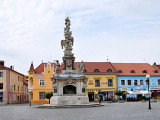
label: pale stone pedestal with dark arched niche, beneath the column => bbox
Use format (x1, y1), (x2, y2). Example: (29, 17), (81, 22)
(50, 73), (89, 106)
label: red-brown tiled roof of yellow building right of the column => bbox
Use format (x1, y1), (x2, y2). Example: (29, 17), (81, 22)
(60, 62), (116, 73)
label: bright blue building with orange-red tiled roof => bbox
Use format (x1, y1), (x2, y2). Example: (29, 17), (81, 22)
(112, 63), (160, 100)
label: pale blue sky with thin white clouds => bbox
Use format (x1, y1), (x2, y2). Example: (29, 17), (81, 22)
(0, 0), (160, 75)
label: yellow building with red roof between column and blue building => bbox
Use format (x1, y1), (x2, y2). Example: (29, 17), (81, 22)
(81, 62), (117, 101)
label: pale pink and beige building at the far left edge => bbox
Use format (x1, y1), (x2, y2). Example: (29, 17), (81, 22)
(0, 61), (27, 104)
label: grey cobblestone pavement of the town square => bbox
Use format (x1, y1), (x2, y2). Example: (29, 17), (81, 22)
(0, 102), (160, 120)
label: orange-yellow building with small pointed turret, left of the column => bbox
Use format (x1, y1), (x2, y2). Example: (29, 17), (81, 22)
(28, 62), (55, 103)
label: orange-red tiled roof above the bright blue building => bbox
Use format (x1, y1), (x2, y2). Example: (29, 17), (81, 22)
(112, 63), (160, 75)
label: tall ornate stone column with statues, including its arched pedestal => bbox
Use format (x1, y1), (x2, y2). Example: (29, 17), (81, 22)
(51, 17), (89, 105)
